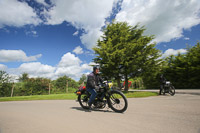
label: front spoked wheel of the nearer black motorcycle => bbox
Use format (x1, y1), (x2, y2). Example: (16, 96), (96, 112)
(108, 91), (128, 113)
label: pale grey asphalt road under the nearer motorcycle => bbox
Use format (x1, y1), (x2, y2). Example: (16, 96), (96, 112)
(0, 94), (200, 133)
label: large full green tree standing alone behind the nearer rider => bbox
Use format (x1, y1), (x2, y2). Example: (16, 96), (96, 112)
(93, 22), (160, 91)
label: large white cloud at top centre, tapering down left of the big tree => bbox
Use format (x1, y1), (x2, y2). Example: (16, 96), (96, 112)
(45, 0), (116, 49)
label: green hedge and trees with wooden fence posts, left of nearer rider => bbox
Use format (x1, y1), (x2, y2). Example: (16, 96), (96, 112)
(0, 71), (86, 97)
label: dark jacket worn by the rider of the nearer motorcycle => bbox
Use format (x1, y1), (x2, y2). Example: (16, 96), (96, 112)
(86, 72), (103, 89)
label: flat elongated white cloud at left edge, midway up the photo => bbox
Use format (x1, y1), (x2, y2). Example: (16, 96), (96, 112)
(0, 50), (42, 62)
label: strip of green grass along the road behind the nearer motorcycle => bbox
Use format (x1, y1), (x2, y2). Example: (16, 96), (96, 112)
(0, 92), (158, 102)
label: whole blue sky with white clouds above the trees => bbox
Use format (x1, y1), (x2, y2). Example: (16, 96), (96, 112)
(0, 0), (200, 80)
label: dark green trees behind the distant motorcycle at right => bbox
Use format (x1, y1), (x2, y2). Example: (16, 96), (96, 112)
(142, 42), (200, 89)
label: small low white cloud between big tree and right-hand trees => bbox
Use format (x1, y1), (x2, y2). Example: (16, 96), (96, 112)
(161, 49), (187, 58)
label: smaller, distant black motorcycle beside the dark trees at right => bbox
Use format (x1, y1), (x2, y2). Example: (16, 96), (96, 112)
(161, 81), (175, 96)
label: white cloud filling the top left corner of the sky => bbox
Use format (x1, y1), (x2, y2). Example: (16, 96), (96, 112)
(0, 0), (42, 28)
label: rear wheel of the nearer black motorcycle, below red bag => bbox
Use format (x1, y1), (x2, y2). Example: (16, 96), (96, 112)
(78, 93), (89, 109)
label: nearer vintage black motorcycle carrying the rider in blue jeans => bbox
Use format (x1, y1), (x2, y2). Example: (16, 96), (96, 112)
(76, 81), (128, 113)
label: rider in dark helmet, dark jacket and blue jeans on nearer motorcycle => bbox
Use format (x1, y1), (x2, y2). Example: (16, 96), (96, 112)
(86, 66), (103, 108)
